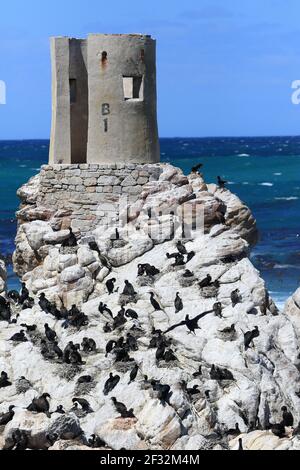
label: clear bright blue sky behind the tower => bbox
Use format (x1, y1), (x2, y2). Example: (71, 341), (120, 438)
(0, 0), (300, 139)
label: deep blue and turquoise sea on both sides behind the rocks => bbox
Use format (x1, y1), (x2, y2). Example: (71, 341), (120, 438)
(0, 137), (300, 305)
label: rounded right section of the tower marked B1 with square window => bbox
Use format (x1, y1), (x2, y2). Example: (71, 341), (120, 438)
(87, 34), (160, 163)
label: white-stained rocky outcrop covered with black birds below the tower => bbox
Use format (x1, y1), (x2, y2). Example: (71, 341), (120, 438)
(0, 165), (300, 450)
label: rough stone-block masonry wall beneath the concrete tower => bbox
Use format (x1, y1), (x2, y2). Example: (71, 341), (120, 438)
(36, 164), (163, 233)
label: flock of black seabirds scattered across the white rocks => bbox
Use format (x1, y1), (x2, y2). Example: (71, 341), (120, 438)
(0, 183), (292, 449)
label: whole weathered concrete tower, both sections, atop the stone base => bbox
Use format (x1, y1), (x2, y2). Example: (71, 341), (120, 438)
(49, 34), (160, 164)
